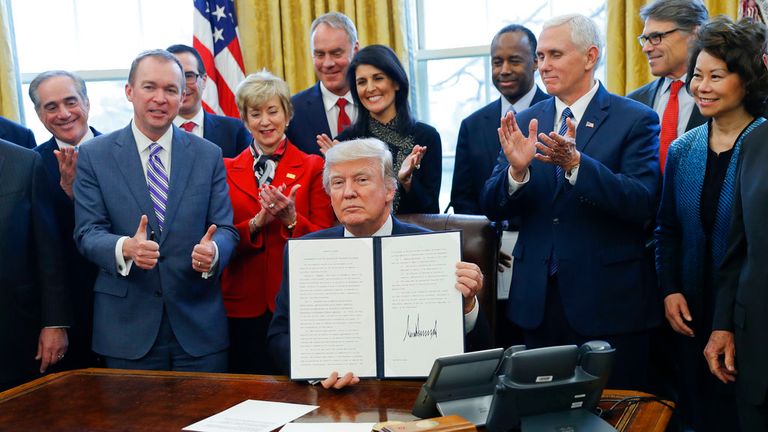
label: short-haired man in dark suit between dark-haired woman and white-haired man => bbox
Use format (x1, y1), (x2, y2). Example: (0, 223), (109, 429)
(451, 24), (549, 214)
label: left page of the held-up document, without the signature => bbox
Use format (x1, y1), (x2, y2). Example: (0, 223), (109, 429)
(288, 238), (376, 379)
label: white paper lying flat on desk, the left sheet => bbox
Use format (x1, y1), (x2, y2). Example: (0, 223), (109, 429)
(182, 399), (317, 432)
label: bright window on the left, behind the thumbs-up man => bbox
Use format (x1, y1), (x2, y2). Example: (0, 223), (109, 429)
(11, 0), (193, 143)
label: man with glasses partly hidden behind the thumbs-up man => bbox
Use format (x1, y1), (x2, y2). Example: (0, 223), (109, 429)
(167, 44), (251, 158)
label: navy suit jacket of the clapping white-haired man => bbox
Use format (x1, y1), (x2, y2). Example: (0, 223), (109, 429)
(480, 84), (659, 336)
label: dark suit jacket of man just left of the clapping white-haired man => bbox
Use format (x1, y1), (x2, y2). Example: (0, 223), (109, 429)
(451, 86), (551, 215)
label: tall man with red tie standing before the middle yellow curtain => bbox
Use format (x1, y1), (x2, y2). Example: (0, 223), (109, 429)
(285, 12), (360, 156)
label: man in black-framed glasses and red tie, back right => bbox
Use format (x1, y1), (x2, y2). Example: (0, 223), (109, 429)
(627, 0), (709, 172)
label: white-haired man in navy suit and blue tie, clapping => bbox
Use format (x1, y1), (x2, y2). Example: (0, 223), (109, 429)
(480, 14), (660, 388)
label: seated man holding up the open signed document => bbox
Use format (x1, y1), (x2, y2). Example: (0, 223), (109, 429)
(267, 138), (488, 388)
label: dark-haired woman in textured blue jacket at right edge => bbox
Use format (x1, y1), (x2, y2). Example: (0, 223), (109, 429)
(656, 17), (768, 432)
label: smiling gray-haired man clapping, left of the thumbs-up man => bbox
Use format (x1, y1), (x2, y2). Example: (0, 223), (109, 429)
(29, 70), (100, 369)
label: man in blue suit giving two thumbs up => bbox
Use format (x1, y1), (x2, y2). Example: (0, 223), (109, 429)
(74, 50), (239, 372)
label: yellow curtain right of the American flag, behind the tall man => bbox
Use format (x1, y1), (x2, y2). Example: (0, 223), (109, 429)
(235, 0), (408, 93)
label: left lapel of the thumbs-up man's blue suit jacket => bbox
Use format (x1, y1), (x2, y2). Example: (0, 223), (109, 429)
(112, 124), (160, 232)
